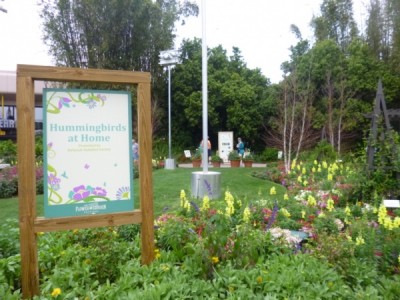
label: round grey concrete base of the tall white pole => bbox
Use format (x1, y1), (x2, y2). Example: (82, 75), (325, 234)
(192, 171), (221, 199)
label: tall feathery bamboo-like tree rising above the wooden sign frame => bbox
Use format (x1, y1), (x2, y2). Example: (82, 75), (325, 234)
(41, 0), (198, 73)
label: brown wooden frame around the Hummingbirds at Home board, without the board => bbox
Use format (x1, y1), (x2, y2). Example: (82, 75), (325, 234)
(16, 65), (154, 298)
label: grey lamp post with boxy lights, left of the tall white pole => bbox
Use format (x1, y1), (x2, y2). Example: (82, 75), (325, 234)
(159, 50), (180, 169)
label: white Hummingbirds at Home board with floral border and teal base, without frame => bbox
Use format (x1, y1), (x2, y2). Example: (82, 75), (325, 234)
(43, 89), (134, 218)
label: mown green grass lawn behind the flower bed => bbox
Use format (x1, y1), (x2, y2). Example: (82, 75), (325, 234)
(0, 168), (285, 220)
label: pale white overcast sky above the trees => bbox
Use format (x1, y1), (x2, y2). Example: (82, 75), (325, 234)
(0, 0), (369, 83)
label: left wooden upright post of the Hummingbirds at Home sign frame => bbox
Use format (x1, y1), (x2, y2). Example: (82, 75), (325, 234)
(16, 72), (39, 298)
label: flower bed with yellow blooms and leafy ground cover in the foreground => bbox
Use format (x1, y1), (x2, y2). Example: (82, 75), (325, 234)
(0, 161), (400, 299)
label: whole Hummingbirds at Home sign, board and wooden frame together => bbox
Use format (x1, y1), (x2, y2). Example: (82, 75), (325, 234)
(16, 65), (154, 298)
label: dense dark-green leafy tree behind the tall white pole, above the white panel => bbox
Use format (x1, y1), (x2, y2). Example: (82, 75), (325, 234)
(173, 39), (269, 150)
